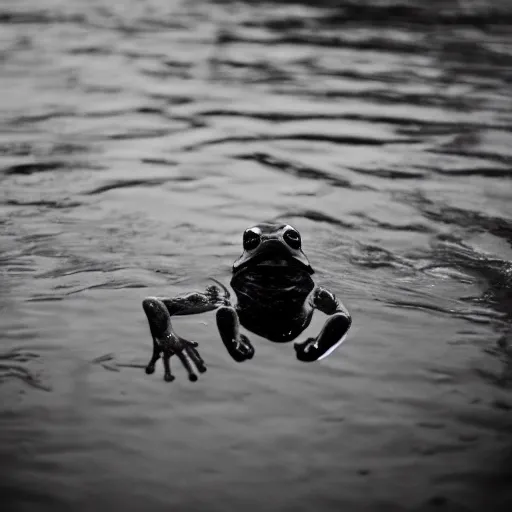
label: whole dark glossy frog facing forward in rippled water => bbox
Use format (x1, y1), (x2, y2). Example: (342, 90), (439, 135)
(142, 223), (352, 382)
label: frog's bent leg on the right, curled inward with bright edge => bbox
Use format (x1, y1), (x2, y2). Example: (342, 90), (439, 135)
(294, 287), (352, 362)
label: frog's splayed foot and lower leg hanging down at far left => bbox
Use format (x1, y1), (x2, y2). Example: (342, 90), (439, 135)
(142, 297), (206, 382)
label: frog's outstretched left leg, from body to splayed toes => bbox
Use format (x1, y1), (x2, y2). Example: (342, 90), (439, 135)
(142, 283), (230, 382)
